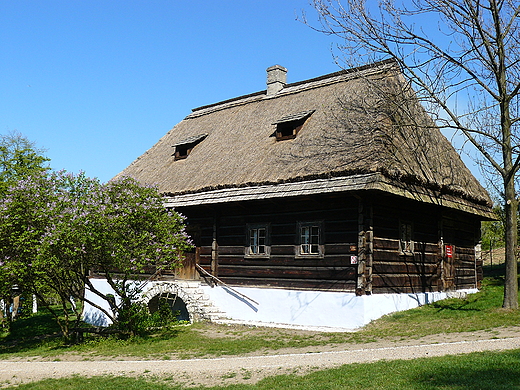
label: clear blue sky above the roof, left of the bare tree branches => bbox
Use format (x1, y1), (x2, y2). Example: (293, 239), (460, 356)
(0, 0), (346, 181)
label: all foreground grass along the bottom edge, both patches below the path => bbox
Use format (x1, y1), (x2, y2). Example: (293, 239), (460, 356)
(7, 350), (520, 390)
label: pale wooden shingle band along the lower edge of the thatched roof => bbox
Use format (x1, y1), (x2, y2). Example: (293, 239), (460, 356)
(164, 173), (494, 219)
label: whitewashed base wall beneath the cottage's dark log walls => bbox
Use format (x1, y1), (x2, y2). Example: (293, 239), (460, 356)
(83, 279), (477, 330)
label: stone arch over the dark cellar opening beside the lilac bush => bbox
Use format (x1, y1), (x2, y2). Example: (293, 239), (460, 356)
(140, 282), (198, 322)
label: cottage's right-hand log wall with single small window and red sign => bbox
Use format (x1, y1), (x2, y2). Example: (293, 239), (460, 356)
(372, 196), (482, 293)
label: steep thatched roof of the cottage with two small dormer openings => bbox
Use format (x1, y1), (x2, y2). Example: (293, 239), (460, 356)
(118, 61), (491, 214)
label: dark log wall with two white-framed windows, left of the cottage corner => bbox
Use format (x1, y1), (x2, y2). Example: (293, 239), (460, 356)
(183, 196), (358, 292)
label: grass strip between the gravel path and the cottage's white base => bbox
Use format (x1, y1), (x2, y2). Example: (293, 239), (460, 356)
(0, 266), (520, 359)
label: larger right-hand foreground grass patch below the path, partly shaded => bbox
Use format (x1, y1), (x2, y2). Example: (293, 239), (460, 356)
(254, 350), (520, 390)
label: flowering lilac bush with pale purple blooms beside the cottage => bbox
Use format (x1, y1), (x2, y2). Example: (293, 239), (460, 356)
(0, 171), (191, 336)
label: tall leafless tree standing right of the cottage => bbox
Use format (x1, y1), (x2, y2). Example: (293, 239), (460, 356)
(306, 0), (520, 309)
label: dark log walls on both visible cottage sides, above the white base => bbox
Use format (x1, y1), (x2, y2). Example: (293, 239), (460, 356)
(180, 193), (482, 294)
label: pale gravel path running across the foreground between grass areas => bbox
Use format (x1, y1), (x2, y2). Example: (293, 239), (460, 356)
(0, 328), (520, 387)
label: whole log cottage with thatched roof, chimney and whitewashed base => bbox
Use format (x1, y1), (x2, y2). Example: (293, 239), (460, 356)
(84, 61), (491, 328)
